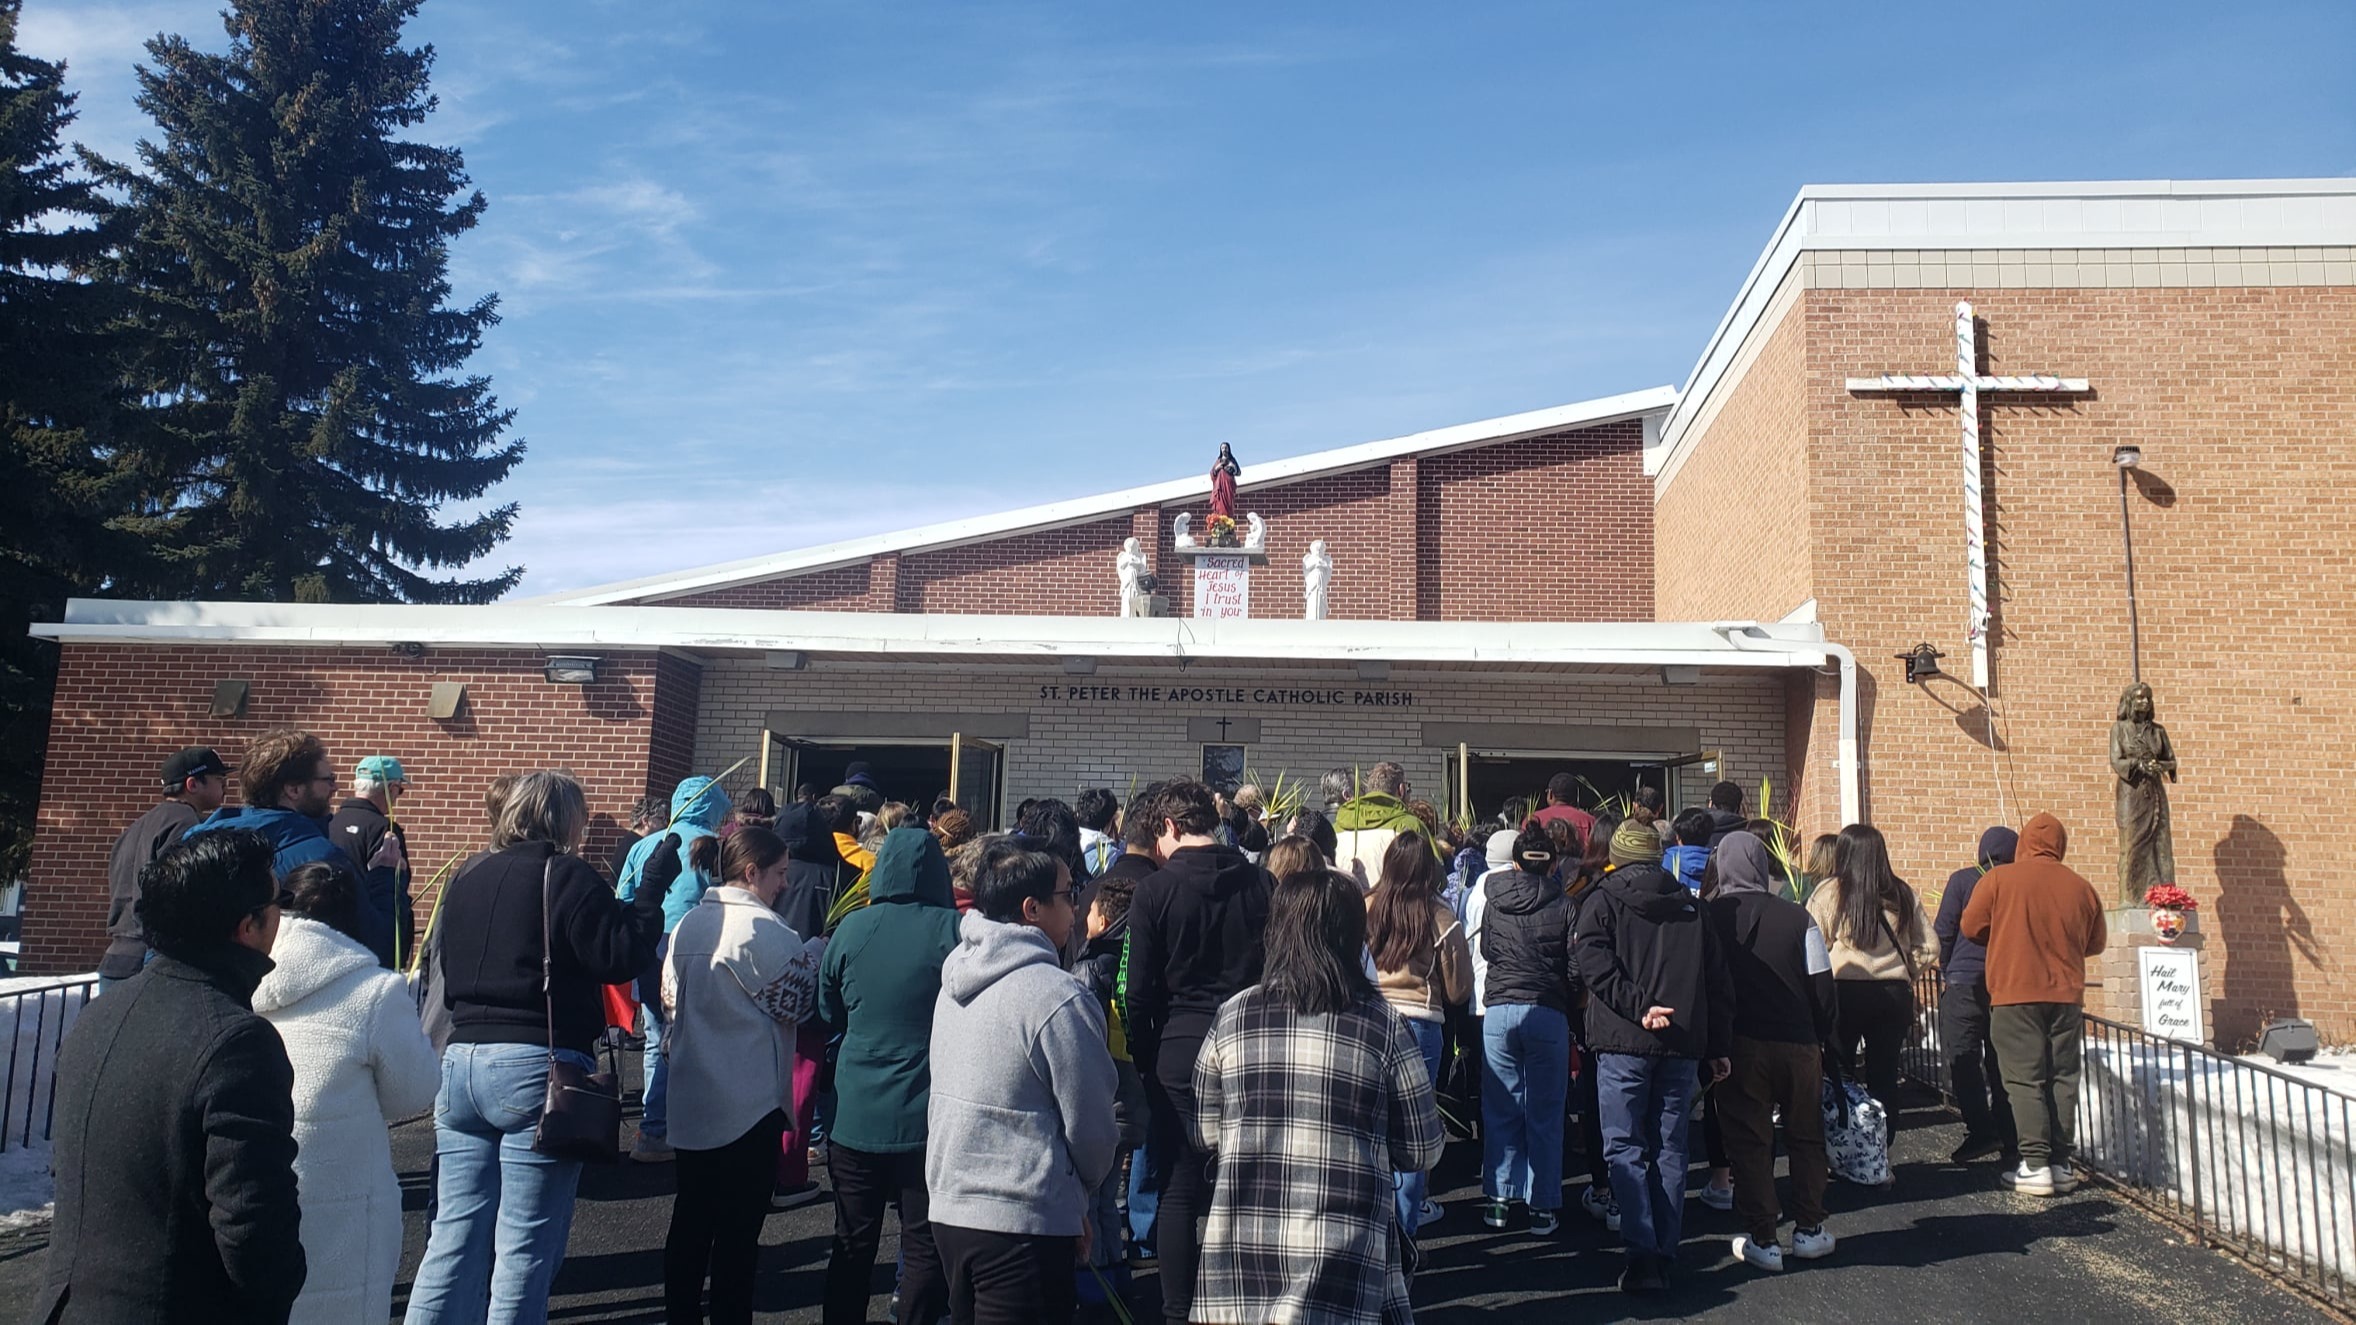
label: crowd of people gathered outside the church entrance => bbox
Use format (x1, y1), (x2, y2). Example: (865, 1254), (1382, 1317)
(42, 731), (2104, 1325)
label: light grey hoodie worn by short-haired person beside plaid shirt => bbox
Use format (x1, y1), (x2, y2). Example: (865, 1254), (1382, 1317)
(924, 912), (1119, 1238)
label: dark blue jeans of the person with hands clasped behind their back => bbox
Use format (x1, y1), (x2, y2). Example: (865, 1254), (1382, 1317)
(1592, 1046), (1701, 1259)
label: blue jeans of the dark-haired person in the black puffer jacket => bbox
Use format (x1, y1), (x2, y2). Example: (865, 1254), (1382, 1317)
(1480, 1002), (1571, 1209)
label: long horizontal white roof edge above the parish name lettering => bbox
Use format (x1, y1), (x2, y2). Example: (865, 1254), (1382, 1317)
(33, 599), (1826, 667)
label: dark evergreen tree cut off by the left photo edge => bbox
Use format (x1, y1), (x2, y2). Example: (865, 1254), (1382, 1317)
(0, 0), (144, 882)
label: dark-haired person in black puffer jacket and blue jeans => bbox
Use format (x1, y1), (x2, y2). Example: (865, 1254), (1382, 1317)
(1480, 820), (1579, 1238)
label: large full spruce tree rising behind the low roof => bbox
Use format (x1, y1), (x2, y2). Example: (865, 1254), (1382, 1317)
(101, 0), (523, 604)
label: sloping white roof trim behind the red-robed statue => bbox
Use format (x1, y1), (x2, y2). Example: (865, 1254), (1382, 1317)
(516, 387), (1677, 606)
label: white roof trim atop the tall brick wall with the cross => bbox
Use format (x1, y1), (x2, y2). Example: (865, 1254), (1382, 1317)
(1647, 179), (2356, 474)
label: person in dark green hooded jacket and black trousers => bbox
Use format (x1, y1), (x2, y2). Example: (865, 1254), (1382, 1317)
(818, 828), (957, 1325)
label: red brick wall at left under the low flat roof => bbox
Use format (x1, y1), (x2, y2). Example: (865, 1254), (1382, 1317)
(24, 644), (697, 971)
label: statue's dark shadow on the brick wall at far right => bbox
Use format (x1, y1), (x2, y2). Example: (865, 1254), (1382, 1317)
(2210, 813), (2323, 1049)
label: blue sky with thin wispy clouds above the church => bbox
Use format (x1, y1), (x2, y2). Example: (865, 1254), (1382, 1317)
(21, 0), (2356, 592)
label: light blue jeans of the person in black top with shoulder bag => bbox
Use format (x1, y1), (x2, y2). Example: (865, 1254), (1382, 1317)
(408, 1044), (596, 1325)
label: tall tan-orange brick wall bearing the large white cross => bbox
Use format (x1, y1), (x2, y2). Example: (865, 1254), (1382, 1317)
(1663, 285), (2356, 1047)
